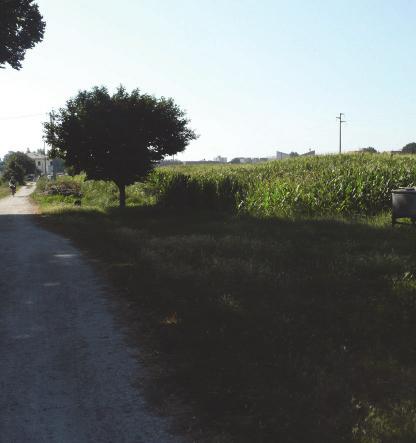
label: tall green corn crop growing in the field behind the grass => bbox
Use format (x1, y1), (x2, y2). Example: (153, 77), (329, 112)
(149, 154), (416, 216)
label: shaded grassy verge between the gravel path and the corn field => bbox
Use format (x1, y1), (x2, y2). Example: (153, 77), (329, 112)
(36, 196), (416, 443)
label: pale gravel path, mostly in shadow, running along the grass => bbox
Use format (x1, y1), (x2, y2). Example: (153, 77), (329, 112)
(0, 187), (179, 443)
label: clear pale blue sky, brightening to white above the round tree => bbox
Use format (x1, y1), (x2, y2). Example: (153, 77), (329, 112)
(0, 0), (416, 160)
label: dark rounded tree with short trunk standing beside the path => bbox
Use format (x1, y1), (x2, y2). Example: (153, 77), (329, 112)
(44, 86), (197, 207)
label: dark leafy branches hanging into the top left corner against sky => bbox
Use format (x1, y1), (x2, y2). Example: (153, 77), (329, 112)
(0, 0), (45, 69)
